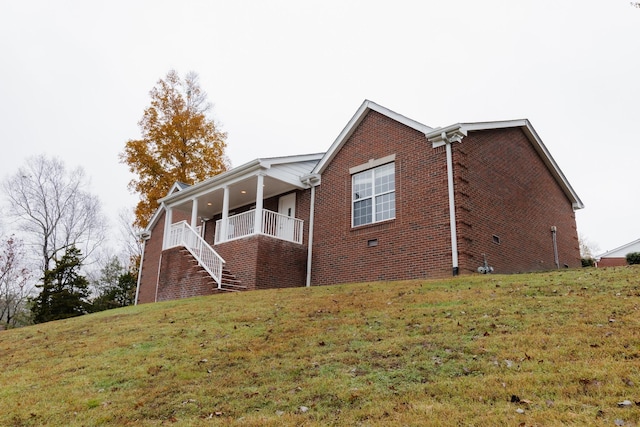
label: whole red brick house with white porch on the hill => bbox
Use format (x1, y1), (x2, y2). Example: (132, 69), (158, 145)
(137, 101), (583, 303)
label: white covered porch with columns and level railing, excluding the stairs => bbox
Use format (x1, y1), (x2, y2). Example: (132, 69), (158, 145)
(160, 155), (319, 249)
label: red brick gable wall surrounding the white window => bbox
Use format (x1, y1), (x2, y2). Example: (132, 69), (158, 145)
(312, 111), (451, 285)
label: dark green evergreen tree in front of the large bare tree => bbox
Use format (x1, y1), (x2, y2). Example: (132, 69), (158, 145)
(31, 246), (89, 323)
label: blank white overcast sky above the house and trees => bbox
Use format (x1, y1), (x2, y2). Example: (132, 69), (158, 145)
(0, 0), (640, 251)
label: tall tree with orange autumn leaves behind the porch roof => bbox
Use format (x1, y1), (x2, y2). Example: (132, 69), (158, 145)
(120, 70), (229, 227)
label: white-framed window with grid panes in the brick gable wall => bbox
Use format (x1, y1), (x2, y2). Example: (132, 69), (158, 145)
(351, 162), (396, 227)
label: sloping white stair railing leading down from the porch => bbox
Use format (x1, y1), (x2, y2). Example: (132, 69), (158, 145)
(165, 221), (224, 289)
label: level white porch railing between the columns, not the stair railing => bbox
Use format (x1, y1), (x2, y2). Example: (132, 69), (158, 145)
(214, 209), (304, 244)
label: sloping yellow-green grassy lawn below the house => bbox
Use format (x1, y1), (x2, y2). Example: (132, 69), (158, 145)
(0, 267), (640, 426)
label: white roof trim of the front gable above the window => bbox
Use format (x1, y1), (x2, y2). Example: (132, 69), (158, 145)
(312, 99), (433, 174)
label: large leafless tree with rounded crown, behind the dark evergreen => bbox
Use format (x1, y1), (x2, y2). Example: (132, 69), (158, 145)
(3, 155), (107, 277)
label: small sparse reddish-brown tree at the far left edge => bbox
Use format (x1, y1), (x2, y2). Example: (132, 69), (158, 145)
(0, 236), (33, 327)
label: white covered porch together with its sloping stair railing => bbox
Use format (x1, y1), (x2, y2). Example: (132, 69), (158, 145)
(160, 154), (321, 287)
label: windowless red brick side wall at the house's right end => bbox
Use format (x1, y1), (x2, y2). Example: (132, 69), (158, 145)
(453, 128), (581, 273)
